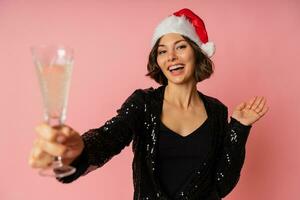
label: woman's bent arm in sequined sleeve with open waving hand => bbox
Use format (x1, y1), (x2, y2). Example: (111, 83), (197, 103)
(216, 96), (269, 197)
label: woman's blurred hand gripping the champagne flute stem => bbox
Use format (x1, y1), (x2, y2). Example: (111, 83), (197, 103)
(28, 123), (84, 168)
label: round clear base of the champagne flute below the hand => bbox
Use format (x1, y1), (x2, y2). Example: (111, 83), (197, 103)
(39, 163), (76, 178)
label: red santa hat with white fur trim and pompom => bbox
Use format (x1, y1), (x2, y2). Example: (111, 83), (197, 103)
(151, 8), (215, 57)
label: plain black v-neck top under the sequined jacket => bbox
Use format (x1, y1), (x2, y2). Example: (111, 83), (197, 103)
(157, 98), (212, 197)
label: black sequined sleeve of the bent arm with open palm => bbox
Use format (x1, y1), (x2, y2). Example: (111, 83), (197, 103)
(215, 107), (252, 197)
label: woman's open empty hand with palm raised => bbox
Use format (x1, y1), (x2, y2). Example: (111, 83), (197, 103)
(232, 96), (269, 125)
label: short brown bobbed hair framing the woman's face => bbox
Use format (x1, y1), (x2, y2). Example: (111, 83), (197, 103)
(146, 35), (214, 85)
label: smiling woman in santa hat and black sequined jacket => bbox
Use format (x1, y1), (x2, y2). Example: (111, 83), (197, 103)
(29, 9), (268, 200)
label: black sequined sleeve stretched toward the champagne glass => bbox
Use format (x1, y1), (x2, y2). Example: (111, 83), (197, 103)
(58, 89), (144, 183)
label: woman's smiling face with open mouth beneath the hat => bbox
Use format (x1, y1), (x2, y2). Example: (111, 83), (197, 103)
(157, 33), (195, 84)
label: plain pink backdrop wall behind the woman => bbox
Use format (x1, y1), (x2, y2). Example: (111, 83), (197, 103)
(0, 0), (300, 200)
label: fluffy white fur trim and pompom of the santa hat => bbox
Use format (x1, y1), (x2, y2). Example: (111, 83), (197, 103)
(151, 15), (215, 57)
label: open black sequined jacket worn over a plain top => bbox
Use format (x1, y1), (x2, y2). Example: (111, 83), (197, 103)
(58, 86), (251, 200)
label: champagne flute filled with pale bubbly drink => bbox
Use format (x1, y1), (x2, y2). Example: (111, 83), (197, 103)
(31, 45), (76, 178)
